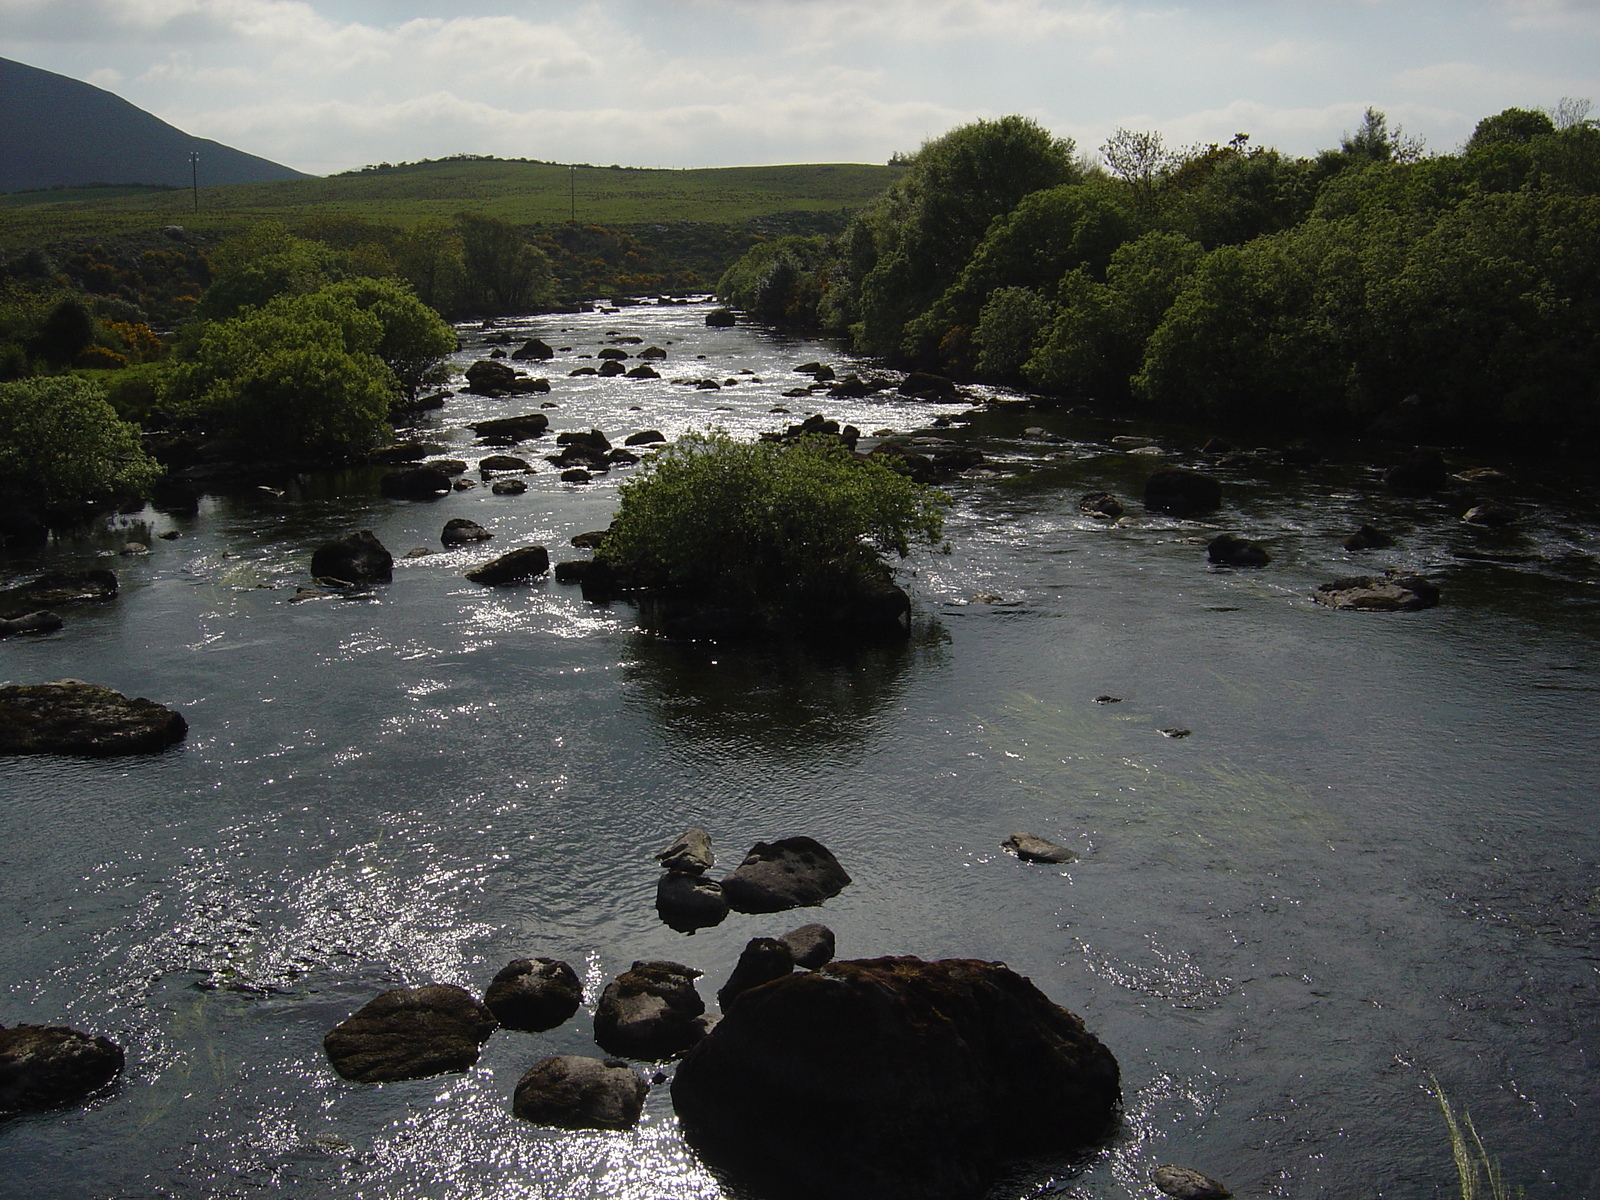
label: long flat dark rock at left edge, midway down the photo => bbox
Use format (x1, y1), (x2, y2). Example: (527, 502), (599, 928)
(0, 678), (189, 758)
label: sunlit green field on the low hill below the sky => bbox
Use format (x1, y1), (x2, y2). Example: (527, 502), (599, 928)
(0, 158), (901, 246)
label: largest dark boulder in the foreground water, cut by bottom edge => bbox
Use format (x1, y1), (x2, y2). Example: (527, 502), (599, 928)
(672, 958), (1120, 1200)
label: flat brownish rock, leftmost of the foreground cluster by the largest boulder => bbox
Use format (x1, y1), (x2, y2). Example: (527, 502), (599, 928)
(322, 984), (496, 1083)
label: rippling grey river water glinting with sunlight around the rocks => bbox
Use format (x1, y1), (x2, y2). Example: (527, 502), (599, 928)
(0, 306), (1600, 1200)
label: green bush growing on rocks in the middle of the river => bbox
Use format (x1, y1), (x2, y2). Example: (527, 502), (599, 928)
(602, 432), (949, 605)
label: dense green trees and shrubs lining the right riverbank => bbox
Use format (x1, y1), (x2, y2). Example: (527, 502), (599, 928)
(718, 102), (1600, 440)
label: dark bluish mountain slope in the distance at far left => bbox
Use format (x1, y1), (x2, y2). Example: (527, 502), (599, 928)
(0, 58), (310, 192)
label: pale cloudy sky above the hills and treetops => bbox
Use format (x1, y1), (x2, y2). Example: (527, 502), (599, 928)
(0, 0), (1600, 174)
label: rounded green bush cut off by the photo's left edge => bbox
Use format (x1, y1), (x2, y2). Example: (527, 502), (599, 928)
(0, 376), (162, 507)
